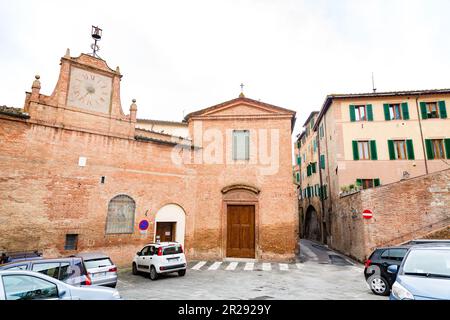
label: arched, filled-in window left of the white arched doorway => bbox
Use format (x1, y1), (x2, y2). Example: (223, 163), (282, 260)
(106, 195), (136, 234)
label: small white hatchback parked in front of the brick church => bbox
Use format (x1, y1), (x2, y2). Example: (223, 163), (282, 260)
(132, 242), (187, 280)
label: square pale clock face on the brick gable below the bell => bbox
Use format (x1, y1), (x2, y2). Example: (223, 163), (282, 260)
(67, 67), (112, 113)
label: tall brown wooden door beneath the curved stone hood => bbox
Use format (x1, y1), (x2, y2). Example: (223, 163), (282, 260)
(227, 205), (255, 259)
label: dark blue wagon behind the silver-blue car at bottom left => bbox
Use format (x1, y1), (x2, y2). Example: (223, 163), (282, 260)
(0, 258), (92, 286)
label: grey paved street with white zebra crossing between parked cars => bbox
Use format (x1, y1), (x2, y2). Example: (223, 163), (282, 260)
(117, 240), (386, 300)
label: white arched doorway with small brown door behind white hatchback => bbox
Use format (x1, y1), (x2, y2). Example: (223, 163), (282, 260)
(155, 204), (186, 246)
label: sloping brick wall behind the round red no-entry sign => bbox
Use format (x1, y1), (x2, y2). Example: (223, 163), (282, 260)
(331, 169), (450, 261)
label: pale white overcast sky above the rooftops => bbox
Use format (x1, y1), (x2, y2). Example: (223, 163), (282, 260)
(0, 0), (450, 132)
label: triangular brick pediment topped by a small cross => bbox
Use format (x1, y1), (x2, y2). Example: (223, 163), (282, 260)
(185, 97), (295, 120)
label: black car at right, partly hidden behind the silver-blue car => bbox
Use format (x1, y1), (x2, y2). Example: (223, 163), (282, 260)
(364, 245), (411, 296)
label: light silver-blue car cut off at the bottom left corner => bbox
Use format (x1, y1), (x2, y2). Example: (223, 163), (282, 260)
(0, 270), (121, 300)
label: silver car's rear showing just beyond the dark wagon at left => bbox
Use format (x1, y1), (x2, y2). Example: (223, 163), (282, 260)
(75, 252), (117, 288)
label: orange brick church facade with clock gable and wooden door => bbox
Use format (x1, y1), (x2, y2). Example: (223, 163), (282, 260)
(0, 51), (298, 265)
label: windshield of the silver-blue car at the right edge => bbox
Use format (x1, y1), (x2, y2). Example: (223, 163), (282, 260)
(403, 249), (450, 278)
